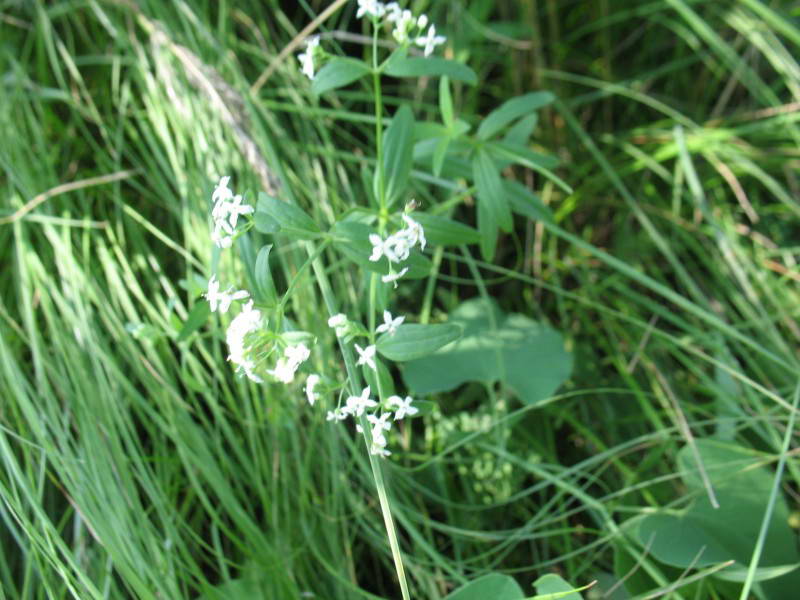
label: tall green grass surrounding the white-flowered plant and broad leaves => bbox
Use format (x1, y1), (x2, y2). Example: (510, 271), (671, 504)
(0, 0), (800, 599)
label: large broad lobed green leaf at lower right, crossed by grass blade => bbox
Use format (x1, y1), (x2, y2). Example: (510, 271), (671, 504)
(637, 439), (800, 600)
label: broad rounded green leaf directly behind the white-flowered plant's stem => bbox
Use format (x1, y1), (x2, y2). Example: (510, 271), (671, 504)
(403, 299), (572, 404)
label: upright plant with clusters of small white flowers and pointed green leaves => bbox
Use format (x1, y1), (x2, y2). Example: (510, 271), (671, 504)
(200, 0), (560, 600)
